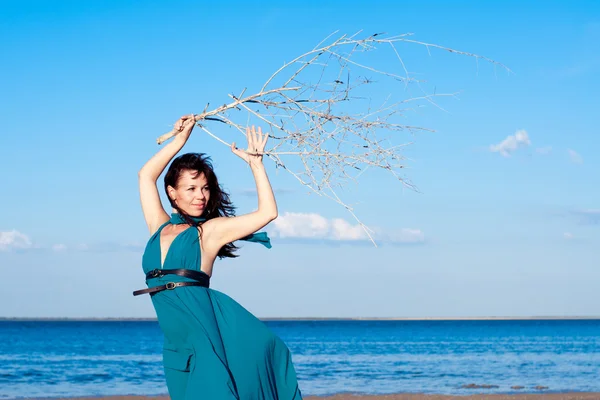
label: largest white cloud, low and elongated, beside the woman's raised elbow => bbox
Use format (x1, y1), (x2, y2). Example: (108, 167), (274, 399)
(270, 212), (425, 243)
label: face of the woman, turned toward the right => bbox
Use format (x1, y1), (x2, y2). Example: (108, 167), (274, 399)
(169, 170), (210, 217)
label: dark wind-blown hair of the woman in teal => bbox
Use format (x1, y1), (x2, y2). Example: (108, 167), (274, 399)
(165, 153), (237, 258)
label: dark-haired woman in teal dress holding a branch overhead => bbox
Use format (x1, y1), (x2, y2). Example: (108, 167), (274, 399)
(134, 115), (302, 400)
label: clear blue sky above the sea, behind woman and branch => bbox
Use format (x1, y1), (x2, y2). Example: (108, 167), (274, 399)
(0, 1), (600, 317)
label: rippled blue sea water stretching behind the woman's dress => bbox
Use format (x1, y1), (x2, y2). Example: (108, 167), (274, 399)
(0, 320), (600, 399)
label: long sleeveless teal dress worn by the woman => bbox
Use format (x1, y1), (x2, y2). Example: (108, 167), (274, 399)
(142, 214), (302, 400)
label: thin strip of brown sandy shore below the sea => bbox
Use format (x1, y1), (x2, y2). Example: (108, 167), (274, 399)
(51, 393), (600, 400)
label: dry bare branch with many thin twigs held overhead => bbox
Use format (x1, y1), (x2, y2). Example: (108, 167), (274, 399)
(157, 32), (508, 244)
